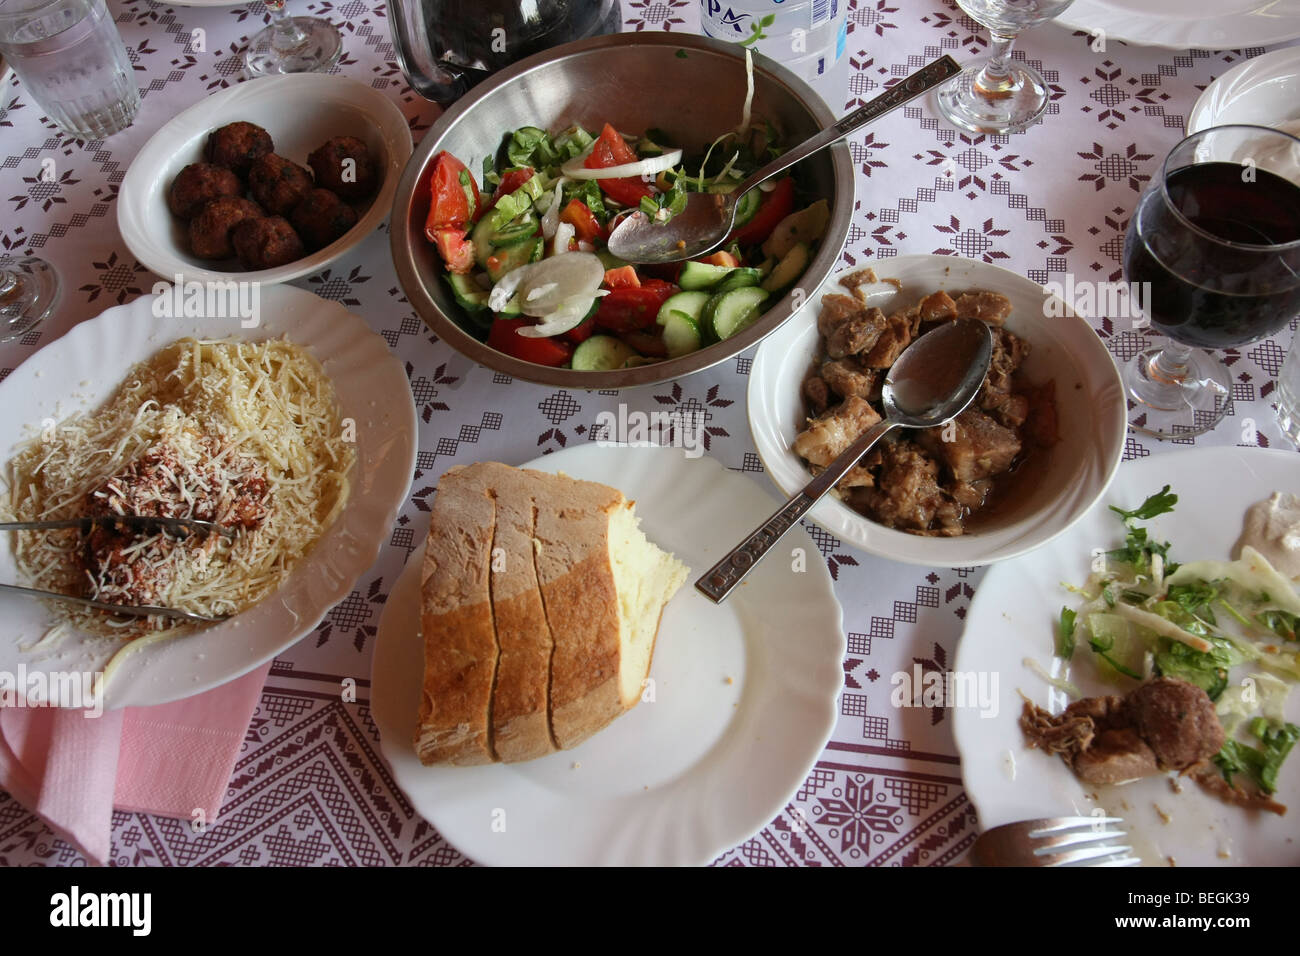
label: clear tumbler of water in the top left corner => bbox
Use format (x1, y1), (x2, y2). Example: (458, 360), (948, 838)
(0, 0), (140, 139)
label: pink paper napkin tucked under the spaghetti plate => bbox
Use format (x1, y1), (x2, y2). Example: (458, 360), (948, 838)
(0, 663), (270, 864)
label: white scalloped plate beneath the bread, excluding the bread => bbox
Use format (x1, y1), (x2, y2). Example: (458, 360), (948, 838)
(371, 444), (845, 866)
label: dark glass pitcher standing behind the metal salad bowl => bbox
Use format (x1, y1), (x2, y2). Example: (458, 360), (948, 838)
(389, 0), (620, 105)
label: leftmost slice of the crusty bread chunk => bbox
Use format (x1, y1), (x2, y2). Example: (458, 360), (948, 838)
(415, 468), (498, 765)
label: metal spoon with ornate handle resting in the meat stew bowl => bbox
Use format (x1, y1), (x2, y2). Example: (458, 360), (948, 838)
(696, 319), (993, 604)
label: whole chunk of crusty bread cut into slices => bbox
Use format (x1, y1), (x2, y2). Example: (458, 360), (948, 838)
(416, 462), (688, 763)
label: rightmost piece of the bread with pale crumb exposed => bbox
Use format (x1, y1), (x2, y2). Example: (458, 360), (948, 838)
(534, 472), (688, 749)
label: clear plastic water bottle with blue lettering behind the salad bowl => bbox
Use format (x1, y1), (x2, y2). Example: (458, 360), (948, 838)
(699, 0), (849, 116)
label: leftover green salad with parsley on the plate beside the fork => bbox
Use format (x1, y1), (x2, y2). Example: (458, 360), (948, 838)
(1052, 485), (1300, 795)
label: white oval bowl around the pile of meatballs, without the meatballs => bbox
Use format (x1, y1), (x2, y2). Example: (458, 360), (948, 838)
(117, 73), (411, 284)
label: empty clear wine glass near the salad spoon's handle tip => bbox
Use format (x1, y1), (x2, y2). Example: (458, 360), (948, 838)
(936, 0), (1074, 133)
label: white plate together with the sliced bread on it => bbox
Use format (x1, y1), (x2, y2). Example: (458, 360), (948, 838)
(372, 444), (845, 865)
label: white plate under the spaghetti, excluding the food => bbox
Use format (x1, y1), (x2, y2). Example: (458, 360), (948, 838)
(0, 280), (416, 708)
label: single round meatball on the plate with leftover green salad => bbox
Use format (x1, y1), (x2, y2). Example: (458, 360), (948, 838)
(1128, 678), (1223, 770)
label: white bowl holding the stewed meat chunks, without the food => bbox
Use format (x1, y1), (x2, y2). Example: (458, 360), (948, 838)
(749, 255), (1127, 567)
